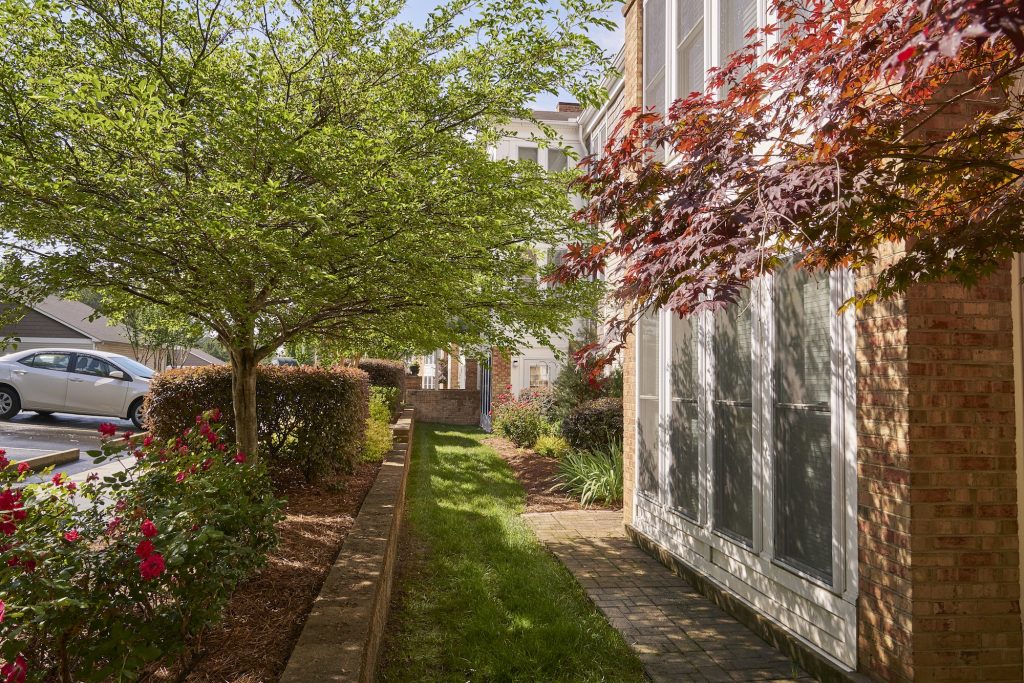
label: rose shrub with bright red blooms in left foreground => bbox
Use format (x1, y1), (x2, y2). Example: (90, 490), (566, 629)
(0, 412), (280, 683)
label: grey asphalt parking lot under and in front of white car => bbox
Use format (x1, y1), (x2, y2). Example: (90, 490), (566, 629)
(0, 413), (137, 474)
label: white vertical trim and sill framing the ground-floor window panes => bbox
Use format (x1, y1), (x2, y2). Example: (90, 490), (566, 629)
(632, 270), (857, 605)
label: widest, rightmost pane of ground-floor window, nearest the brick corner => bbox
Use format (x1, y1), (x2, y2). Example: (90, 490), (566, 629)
(773, 267), (833, 581)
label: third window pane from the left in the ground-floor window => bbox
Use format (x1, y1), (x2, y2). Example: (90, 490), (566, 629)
(712, 292), (754, 544)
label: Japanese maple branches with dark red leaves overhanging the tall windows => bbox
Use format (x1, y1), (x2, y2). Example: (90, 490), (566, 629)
(555, 0), (1024, 362)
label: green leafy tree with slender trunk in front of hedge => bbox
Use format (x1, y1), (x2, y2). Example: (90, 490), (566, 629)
(0, 0), (612, 452)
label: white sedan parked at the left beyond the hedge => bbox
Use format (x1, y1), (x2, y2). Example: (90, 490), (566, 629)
(0, 348), (154, 428)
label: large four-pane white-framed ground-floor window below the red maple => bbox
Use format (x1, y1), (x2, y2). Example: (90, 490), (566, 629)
(635, 266), (856, 595)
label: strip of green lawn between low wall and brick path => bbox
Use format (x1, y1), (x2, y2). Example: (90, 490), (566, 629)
(380, 424), (645, 683)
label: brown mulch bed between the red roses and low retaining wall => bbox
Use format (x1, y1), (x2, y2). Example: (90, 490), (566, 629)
(147, 463), (381, 683)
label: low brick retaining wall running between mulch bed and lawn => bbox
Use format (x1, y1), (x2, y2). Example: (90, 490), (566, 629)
(281, 409), (415, 683)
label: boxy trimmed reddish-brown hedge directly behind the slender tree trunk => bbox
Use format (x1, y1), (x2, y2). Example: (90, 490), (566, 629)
(144, 366), (370, 479)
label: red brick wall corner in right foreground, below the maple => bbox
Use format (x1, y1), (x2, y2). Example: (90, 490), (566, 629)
(857, 253), (1024, 681)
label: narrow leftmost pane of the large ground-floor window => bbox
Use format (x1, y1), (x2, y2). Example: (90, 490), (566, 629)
(637, 312), (658, 498)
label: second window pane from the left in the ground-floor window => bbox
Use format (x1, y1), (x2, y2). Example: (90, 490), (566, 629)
(669, 314), (700, 518)
